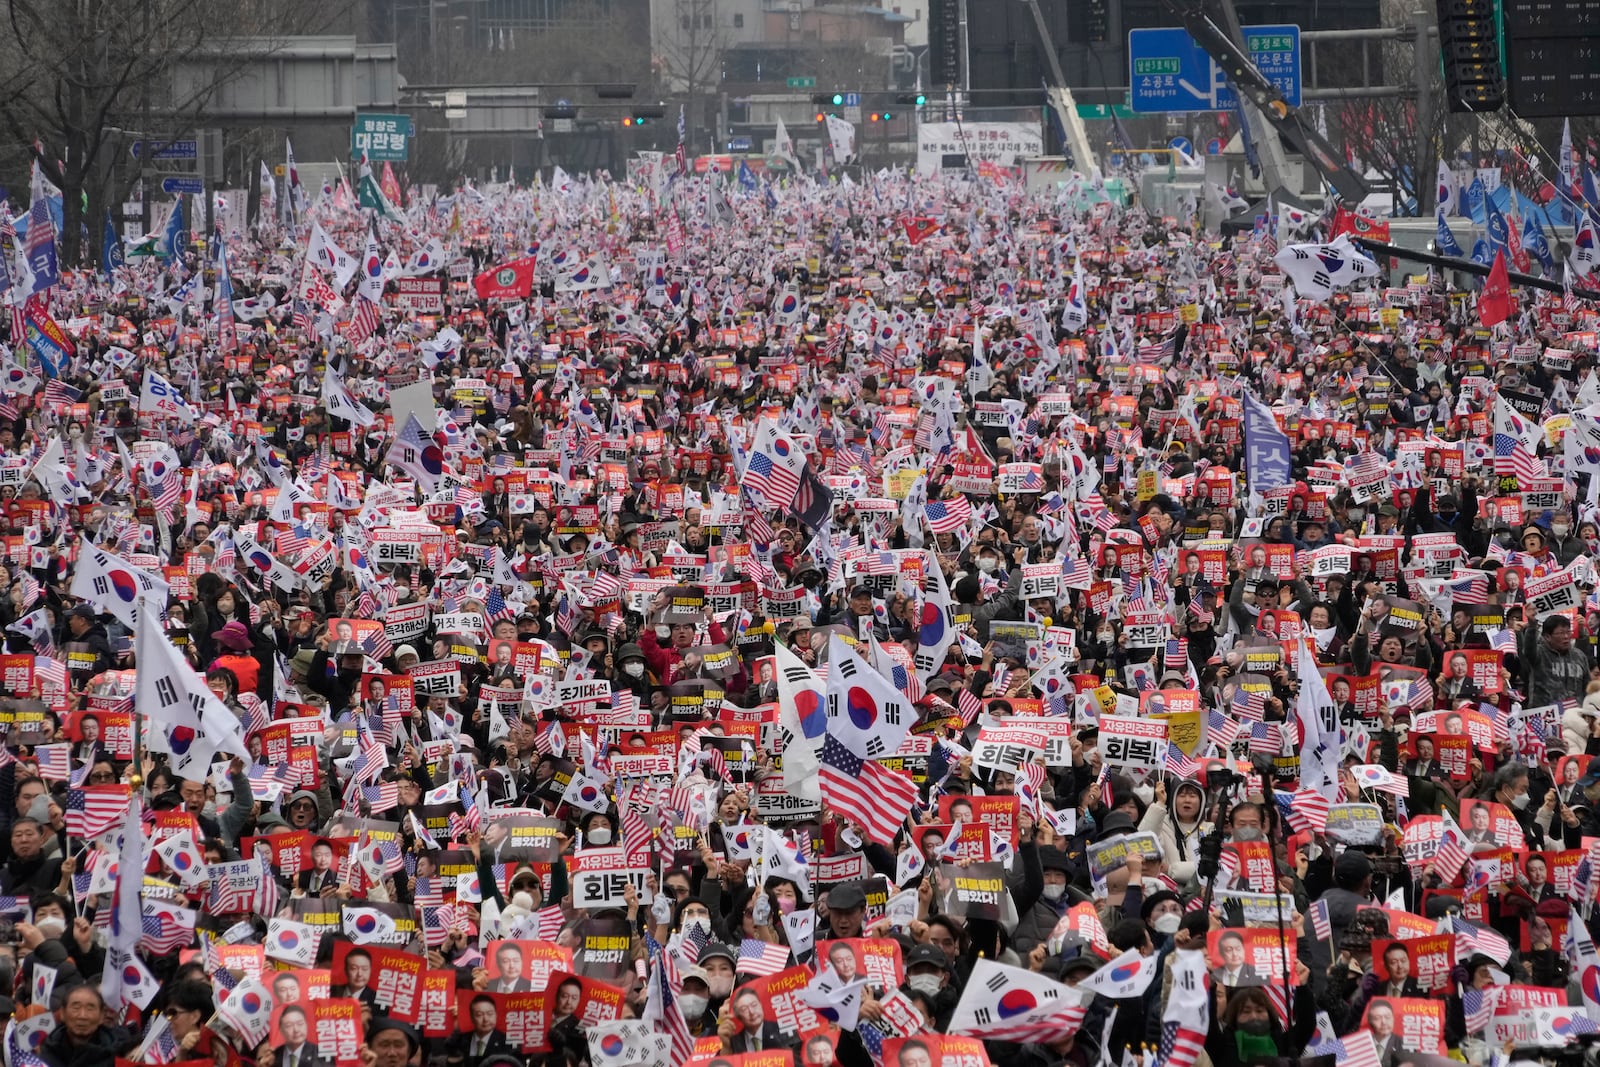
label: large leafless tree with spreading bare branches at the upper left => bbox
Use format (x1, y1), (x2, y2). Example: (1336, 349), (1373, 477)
(0, 0), (349, 264)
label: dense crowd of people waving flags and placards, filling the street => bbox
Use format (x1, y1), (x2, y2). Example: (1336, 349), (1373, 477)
(0, 147), (1600, 1067)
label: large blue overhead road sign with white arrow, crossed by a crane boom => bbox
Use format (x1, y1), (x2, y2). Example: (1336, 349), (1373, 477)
(1128, 26), (1301, 112)
